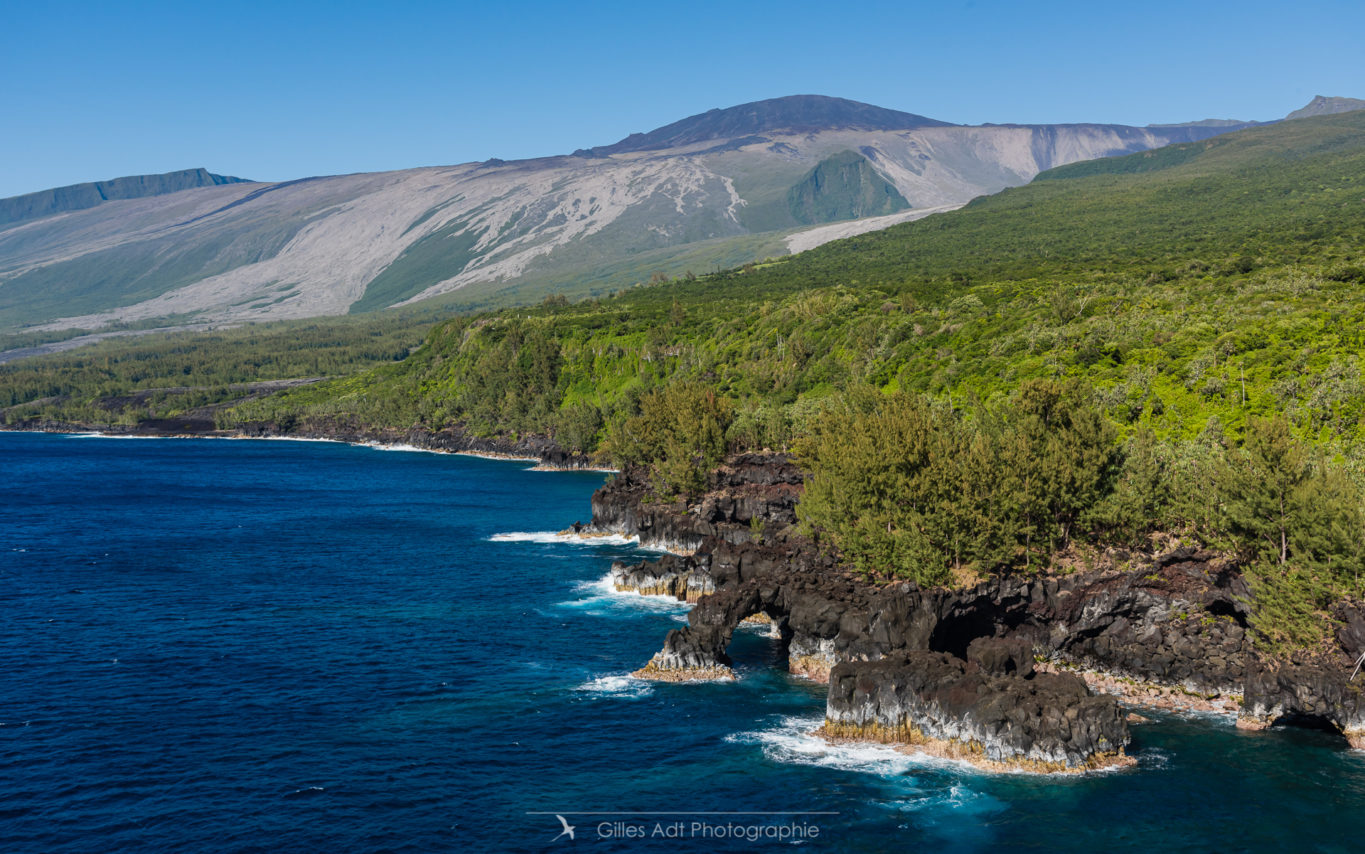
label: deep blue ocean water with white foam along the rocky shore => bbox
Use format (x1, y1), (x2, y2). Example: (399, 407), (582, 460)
(0, 434), (1365, 853)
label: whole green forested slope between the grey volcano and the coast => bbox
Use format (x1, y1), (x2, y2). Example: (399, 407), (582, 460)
(0, 112), (1365, 645)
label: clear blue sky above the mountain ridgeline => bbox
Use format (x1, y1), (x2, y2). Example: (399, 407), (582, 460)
(0, 0), (1365, 196)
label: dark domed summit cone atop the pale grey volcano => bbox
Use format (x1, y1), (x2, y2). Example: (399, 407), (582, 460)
(592, 95), (950, 154)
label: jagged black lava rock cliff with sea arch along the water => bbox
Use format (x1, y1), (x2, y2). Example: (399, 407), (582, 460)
(594, 454), (1365, 771)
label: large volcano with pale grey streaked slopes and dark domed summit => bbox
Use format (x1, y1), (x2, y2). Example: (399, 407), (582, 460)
(0, 95), (1248, 329)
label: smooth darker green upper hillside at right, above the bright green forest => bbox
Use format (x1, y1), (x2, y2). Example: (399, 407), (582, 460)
(720, 112), (1365, 297)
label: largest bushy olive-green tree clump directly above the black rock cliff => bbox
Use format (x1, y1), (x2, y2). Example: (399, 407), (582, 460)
(799, 379), (1121, 584)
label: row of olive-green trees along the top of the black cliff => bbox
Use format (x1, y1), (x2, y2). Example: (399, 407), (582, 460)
(797, 379), (1365, 647)
